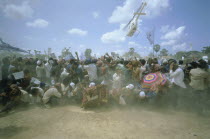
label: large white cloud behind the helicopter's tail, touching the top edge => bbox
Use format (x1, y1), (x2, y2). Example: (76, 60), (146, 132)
(108, 0), (169, 23)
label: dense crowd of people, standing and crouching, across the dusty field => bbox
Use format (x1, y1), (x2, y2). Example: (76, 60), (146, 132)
(0, 53), (210, 113)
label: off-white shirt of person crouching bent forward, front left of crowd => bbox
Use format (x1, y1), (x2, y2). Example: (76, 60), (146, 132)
(42, 88), (61, 104)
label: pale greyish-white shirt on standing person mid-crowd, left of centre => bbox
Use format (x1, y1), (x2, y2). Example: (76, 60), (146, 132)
(84, 64), (98, 81)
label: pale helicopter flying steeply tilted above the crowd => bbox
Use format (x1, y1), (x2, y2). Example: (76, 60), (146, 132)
(124, 2), (147, 37)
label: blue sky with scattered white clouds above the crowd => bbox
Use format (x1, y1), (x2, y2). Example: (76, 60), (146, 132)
(0, 0), (210, 56)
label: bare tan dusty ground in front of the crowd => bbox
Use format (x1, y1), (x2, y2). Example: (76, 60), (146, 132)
(0, 106), (210, 139)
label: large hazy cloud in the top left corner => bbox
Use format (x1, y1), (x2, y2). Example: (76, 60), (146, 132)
(3, 2), (34, 19)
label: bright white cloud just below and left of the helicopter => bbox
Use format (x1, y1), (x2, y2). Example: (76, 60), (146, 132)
(101, 25), (126, 43)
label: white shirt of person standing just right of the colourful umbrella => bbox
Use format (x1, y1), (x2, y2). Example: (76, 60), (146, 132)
(170, 67), (186, 88)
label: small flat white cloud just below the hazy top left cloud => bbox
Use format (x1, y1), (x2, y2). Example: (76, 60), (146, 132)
(26, 19), (49, 28)
